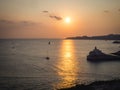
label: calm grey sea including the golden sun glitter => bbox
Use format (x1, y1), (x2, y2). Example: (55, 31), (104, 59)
(0, 39), (120, 90)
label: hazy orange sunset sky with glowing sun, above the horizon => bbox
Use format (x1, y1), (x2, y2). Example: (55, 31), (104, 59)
(0, 0), (120, 38)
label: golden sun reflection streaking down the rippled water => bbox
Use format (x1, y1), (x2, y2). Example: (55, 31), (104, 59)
(57, 40), (78, 88)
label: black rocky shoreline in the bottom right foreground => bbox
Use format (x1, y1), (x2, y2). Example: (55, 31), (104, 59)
(59, 79), (120, 90)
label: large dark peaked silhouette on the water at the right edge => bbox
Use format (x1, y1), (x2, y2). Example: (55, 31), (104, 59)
(87, 47), (120, 61)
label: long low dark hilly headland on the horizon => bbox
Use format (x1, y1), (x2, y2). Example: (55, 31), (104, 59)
(66, 34), (120, 40)
